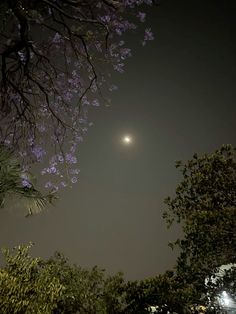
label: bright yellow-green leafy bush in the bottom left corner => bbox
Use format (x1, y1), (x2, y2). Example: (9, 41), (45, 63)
(0, 246), (64, 314)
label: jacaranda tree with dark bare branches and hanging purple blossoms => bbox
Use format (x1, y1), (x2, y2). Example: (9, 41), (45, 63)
(0, 0), (156, 190)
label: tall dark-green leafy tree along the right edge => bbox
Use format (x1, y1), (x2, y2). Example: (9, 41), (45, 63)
(164, 145), (236, 312)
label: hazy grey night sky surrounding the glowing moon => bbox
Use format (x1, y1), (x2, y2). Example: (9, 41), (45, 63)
(0, 0), (236, 279)
